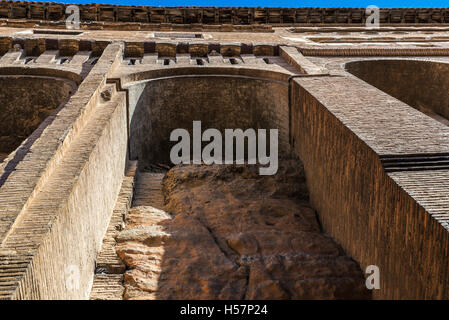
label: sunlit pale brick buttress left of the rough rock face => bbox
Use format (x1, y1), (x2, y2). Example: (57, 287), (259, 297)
(0, 44), (127, 299)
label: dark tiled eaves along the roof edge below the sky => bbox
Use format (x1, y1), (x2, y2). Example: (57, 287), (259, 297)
(0, 1), (449, 28)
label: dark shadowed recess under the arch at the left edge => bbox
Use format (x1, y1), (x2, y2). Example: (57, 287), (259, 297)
(0, 75), (76, 186)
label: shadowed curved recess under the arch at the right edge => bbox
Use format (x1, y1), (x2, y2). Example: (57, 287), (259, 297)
(346, 59), (449, 125)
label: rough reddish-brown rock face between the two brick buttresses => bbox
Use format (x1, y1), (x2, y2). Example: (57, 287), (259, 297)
(116, 160), (369, 299)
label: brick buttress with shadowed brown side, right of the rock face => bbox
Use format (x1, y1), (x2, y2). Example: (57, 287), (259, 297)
(292, 77), (449, 299)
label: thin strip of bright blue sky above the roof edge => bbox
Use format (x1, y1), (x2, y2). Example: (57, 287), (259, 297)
(34, 0), (449, 8)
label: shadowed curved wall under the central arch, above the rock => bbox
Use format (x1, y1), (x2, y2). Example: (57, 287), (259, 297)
(128, 76), (289, 166)
